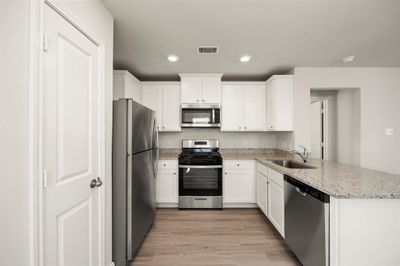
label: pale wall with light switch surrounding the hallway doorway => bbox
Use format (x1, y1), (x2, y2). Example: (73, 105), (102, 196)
(293, 68), (400, 174)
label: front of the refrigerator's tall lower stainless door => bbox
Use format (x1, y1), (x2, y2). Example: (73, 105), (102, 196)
(127, 150), (156, 255)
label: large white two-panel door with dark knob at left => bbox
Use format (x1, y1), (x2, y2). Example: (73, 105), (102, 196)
(42, 5), (104, 266)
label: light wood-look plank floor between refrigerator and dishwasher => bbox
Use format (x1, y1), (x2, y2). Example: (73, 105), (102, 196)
(132, 209), (301, 266)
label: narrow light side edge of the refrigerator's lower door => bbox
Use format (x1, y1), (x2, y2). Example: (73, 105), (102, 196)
(126, 154), (133, 260)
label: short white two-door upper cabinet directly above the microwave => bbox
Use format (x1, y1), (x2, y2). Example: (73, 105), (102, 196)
(179, 74), (222, 104)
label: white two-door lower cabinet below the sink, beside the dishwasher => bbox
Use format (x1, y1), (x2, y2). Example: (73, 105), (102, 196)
(257, 163), (285, 237)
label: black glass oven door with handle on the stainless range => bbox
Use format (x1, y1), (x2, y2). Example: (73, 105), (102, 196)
(179, 165), (222, 196)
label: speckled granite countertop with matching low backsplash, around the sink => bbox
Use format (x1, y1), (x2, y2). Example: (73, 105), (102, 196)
(160, 149), (400, 199)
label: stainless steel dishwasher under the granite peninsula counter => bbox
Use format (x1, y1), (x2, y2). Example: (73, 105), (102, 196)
(284, 175), (329, 266)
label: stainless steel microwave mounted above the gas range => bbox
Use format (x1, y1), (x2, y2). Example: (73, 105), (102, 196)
(181, 104), (221, 127)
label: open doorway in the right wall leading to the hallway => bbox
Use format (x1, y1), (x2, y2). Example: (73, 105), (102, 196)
(310, 88), (361, 166)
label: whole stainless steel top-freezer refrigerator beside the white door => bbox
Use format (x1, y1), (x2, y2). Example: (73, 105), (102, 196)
(112, 99), (158, 266)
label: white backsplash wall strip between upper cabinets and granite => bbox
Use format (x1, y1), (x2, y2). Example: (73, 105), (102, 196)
(159, 128), (280, 149)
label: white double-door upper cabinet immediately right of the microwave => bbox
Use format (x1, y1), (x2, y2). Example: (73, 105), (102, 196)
(221, 82), (267, 131)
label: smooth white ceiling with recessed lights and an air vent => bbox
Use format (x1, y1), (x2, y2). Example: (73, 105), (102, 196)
(103, 0), (400, 80)
